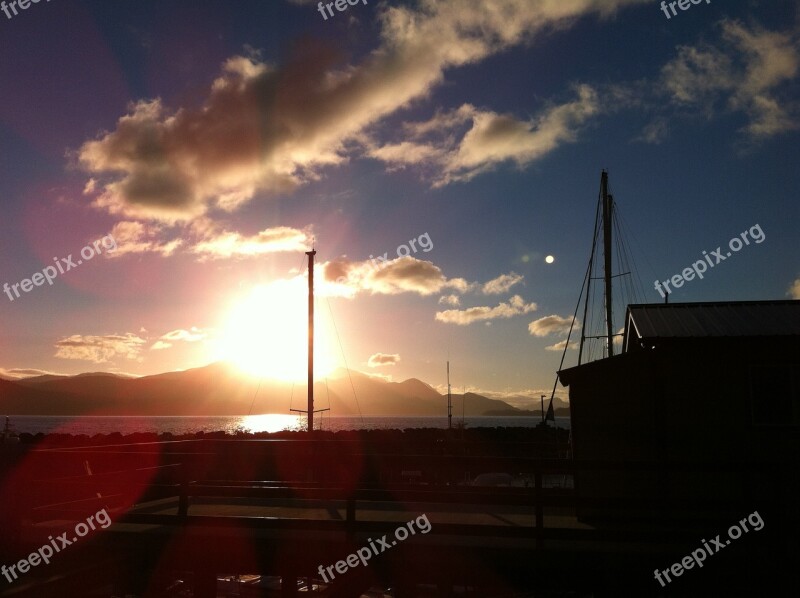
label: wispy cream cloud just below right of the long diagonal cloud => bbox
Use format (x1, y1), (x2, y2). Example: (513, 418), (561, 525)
(369, 85), (601, 187)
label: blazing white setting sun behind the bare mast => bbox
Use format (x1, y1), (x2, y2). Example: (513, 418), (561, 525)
(217, 277), (336, 382)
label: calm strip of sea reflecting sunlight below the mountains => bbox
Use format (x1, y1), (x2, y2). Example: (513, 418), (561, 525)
(4, 413), (569, 436)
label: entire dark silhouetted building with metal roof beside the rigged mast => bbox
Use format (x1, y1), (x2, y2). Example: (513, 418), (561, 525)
(559, 301), (800, 515)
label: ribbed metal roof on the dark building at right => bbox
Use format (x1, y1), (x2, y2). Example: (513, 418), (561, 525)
(625, 301), (800, 339)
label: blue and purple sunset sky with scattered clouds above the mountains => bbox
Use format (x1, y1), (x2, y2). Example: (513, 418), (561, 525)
(0, 0), (800, 406)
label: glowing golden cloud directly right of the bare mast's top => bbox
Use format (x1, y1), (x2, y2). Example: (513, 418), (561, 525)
(320, 256), (470, 297)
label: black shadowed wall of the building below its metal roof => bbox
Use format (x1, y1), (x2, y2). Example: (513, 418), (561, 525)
(565, 337), (800, 524)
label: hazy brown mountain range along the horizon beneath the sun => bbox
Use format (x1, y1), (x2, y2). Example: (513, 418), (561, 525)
(0, 362), (568, 417)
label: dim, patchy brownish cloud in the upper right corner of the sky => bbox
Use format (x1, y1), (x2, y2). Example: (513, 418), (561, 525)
(661, 19), (800, 139)
